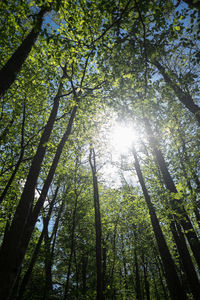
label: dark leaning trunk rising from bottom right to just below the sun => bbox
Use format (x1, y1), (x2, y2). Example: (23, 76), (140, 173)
(133, 148), (187, 300)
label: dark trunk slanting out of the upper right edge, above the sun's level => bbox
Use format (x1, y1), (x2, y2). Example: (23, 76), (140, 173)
(151, 59), (200, 125)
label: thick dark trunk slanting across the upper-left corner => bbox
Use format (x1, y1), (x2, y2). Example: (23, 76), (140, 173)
(0, 8), (47, 98)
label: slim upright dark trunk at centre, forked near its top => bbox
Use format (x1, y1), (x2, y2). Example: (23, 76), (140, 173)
(89, 148), (104, 300)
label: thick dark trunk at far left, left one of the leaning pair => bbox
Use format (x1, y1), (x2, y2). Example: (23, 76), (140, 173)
(0, 83), (62, 300)
